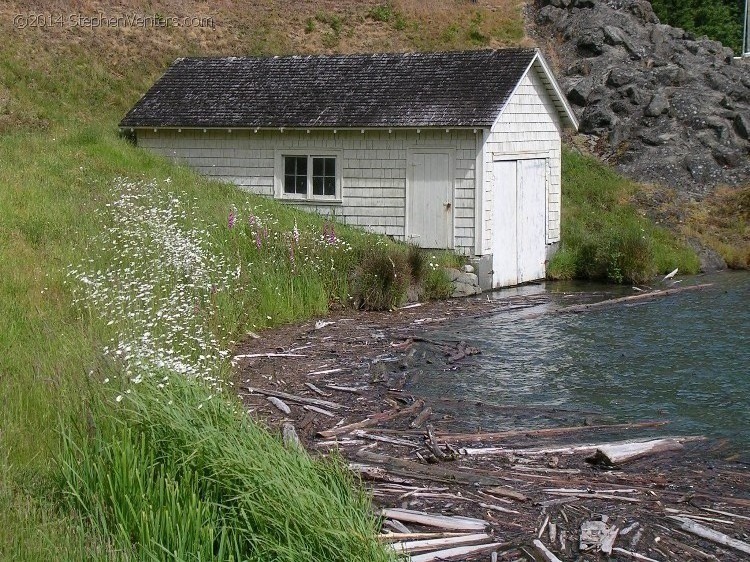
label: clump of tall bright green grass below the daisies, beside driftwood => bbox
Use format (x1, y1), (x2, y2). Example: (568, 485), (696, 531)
(60, 377), (390, 562)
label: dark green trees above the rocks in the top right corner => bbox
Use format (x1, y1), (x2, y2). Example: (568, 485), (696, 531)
(651, 0), (745, 53)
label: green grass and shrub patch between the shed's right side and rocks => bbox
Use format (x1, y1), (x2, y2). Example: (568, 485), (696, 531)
(548, 150), (700, 283)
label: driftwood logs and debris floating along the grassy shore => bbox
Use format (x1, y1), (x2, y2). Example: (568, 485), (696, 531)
(238, 286), (750, 562)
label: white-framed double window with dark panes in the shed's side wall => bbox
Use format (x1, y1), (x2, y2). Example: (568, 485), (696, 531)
(279, 154), (340, 200)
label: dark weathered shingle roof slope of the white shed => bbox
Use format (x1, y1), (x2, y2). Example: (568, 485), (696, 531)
(120, 49), (536, 128)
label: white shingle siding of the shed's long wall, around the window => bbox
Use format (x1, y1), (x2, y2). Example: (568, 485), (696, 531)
(138, 129), (482, 255)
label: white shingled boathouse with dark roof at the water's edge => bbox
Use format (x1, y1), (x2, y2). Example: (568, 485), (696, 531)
(120, 49), (578, 289)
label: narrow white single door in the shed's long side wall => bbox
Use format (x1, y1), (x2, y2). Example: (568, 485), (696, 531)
(406, 150), (453, 248)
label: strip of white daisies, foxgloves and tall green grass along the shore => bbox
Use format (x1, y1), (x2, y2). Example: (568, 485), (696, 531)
(58, 178), (408, 561)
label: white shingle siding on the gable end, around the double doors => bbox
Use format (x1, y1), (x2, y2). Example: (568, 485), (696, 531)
(482, 64), (563, 252)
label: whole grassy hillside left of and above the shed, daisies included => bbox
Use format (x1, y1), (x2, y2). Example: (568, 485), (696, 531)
(0, 0), (704, 562)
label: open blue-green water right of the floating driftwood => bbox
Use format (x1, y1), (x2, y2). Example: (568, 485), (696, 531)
(410, 273), (750, 450)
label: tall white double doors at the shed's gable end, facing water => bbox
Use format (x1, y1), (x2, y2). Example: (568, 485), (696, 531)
(492, 158), (547, 287)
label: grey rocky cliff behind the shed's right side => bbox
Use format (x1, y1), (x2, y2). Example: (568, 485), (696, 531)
(530, 0), (750, 198)
